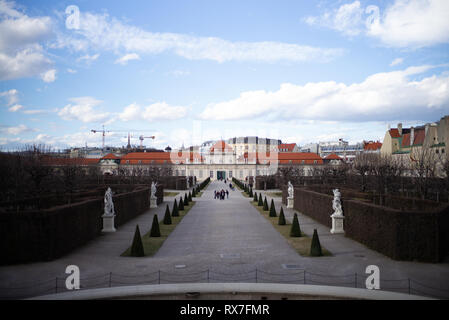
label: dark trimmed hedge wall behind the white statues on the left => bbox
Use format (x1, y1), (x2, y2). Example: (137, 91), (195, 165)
(0, 187), (150, 265)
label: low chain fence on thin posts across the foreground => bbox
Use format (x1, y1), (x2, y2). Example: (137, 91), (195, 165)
(0, 269), (449, 300)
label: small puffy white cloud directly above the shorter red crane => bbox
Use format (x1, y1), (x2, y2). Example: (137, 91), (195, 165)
(119, 102), (187, 122)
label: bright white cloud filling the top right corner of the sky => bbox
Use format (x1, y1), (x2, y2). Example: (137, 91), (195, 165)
(305, 0), (449, 48)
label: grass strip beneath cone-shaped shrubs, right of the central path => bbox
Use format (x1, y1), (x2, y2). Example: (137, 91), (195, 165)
(251, 201), (332, 257)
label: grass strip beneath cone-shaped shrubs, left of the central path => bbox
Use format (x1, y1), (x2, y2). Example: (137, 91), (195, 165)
(121, 201), (195, 257)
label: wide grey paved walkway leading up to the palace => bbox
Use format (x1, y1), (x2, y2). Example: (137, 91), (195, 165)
(0, 181), (449, 296)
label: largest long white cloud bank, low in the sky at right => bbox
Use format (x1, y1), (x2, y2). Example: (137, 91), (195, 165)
(200, 66), (449, 121)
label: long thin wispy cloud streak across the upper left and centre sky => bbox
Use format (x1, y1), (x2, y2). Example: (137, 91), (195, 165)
(55, 12), (343, 63)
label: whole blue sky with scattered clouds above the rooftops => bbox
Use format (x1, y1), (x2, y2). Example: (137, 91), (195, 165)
(0, 0), (449, 150)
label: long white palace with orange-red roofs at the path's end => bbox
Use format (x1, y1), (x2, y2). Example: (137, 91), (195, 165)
(89, 141), (324, 181)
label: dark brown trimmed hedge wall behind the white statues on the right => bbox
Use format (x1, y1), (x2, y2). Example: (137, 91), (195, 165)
(294, 188), (449, 263)
